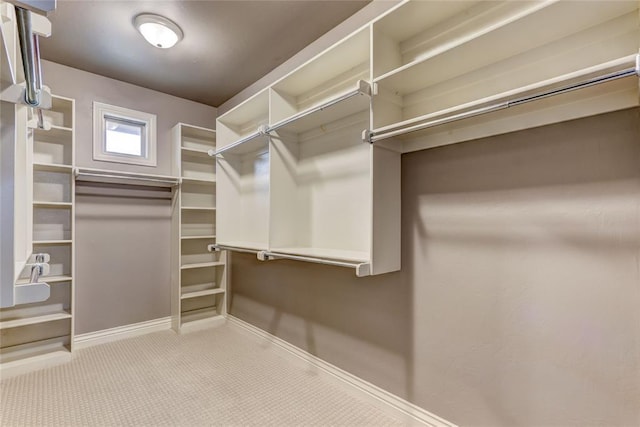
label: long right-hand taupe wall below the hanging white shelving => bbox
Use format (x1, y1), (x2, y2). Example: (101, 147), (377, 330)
(231, 109), (640, 426)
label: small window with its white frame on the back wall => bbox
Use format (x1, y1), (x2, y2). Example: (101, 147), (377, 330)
(93, 102), (156, 166)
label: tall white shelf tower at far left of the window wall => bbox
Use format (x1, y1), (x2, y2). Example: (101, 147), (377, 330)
(0, 96), (75, 372)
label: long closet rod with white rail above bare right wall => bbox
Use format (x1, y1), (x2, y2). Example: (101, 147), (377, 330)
(364, 55), (640, 143)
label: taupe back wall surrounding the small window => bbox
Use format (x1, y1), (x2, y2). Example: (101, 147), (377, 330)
(43, 61), (216, 334)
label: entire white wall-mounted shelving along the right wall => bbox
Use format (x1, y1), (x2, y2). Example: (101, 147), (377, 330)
(214, 0), (640, 276)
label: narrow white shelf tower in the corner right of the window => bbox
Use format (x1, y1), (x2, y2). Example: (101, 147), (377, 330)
(171, 123), (227, 332)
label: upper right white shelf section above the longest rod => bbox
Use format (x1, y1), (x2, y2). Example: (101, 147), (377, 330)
(364, 1), (640, 152)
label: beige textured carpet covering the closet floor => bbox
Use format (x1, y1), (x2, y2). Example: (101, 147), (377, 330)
(0, 326), (402, 427)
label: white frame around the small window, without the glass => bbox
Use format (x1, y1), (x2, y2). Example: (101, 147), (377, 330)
(93, 101), (157, 166)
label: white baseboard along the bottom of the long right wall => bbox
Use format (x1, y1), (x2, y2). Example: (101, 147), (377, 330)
(227, 315), (455, 427)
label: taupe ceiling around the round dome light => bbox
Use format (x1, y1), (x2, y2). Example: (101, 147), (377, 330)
(40, 0), (370, 107)
